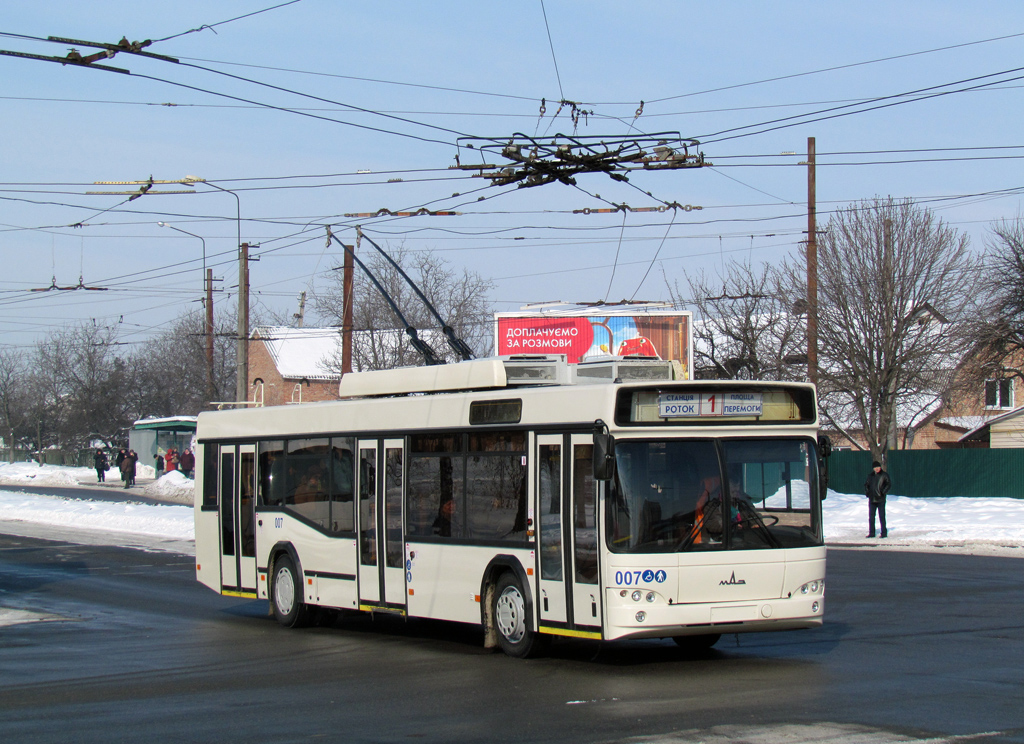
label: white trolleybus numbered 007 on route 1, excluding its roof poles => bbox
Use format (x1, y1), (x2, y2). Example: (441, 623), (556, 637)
(196, 357), (827, 656)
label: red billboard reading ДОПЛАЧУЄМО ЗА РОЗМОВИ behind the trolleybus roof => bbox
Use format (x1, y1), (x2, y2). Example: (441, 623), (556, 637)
(495, 306), (692, 379)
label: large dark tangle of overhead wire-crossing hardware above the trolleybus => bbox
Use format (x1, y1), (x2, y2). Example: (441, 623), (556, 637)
(450, 132), (712, 188)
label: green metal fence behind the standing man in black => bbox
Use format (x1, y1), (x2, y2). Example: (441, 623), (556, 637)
(828, 449), (1024, 498)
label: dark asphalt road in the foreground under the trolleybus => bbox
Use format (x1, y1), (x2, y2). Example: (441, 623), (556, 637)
(0, 535), (1024, 744)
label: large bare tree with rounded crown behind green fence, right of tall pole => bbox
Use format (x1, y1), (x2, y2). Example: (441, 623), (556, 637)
(786, 198), (978, 459)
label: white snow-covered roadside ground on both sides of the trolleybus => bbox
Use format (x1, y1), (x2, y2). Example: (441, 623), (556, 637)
(0, 463), (1024, 558)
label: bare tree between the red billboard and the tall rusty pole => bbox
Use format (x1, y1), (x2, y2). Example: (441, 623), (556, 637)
(667, 262), (806, 380)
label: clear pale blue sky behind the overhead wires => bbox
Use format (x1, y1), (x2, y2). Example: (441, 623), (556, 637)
(0, 0), (1024, 348)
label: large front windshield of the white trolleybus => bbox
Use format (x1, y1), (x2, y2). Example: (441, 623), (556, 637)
(606, 438), (822, 554)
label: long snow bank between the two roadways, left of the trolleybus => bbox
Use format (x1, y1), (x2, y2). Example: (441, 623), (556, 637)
(0, 491), (196, 540)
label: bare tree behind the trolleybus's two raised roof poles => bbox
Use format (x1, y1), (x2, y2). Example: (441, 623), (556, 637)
(312, 245), (494, 369)
